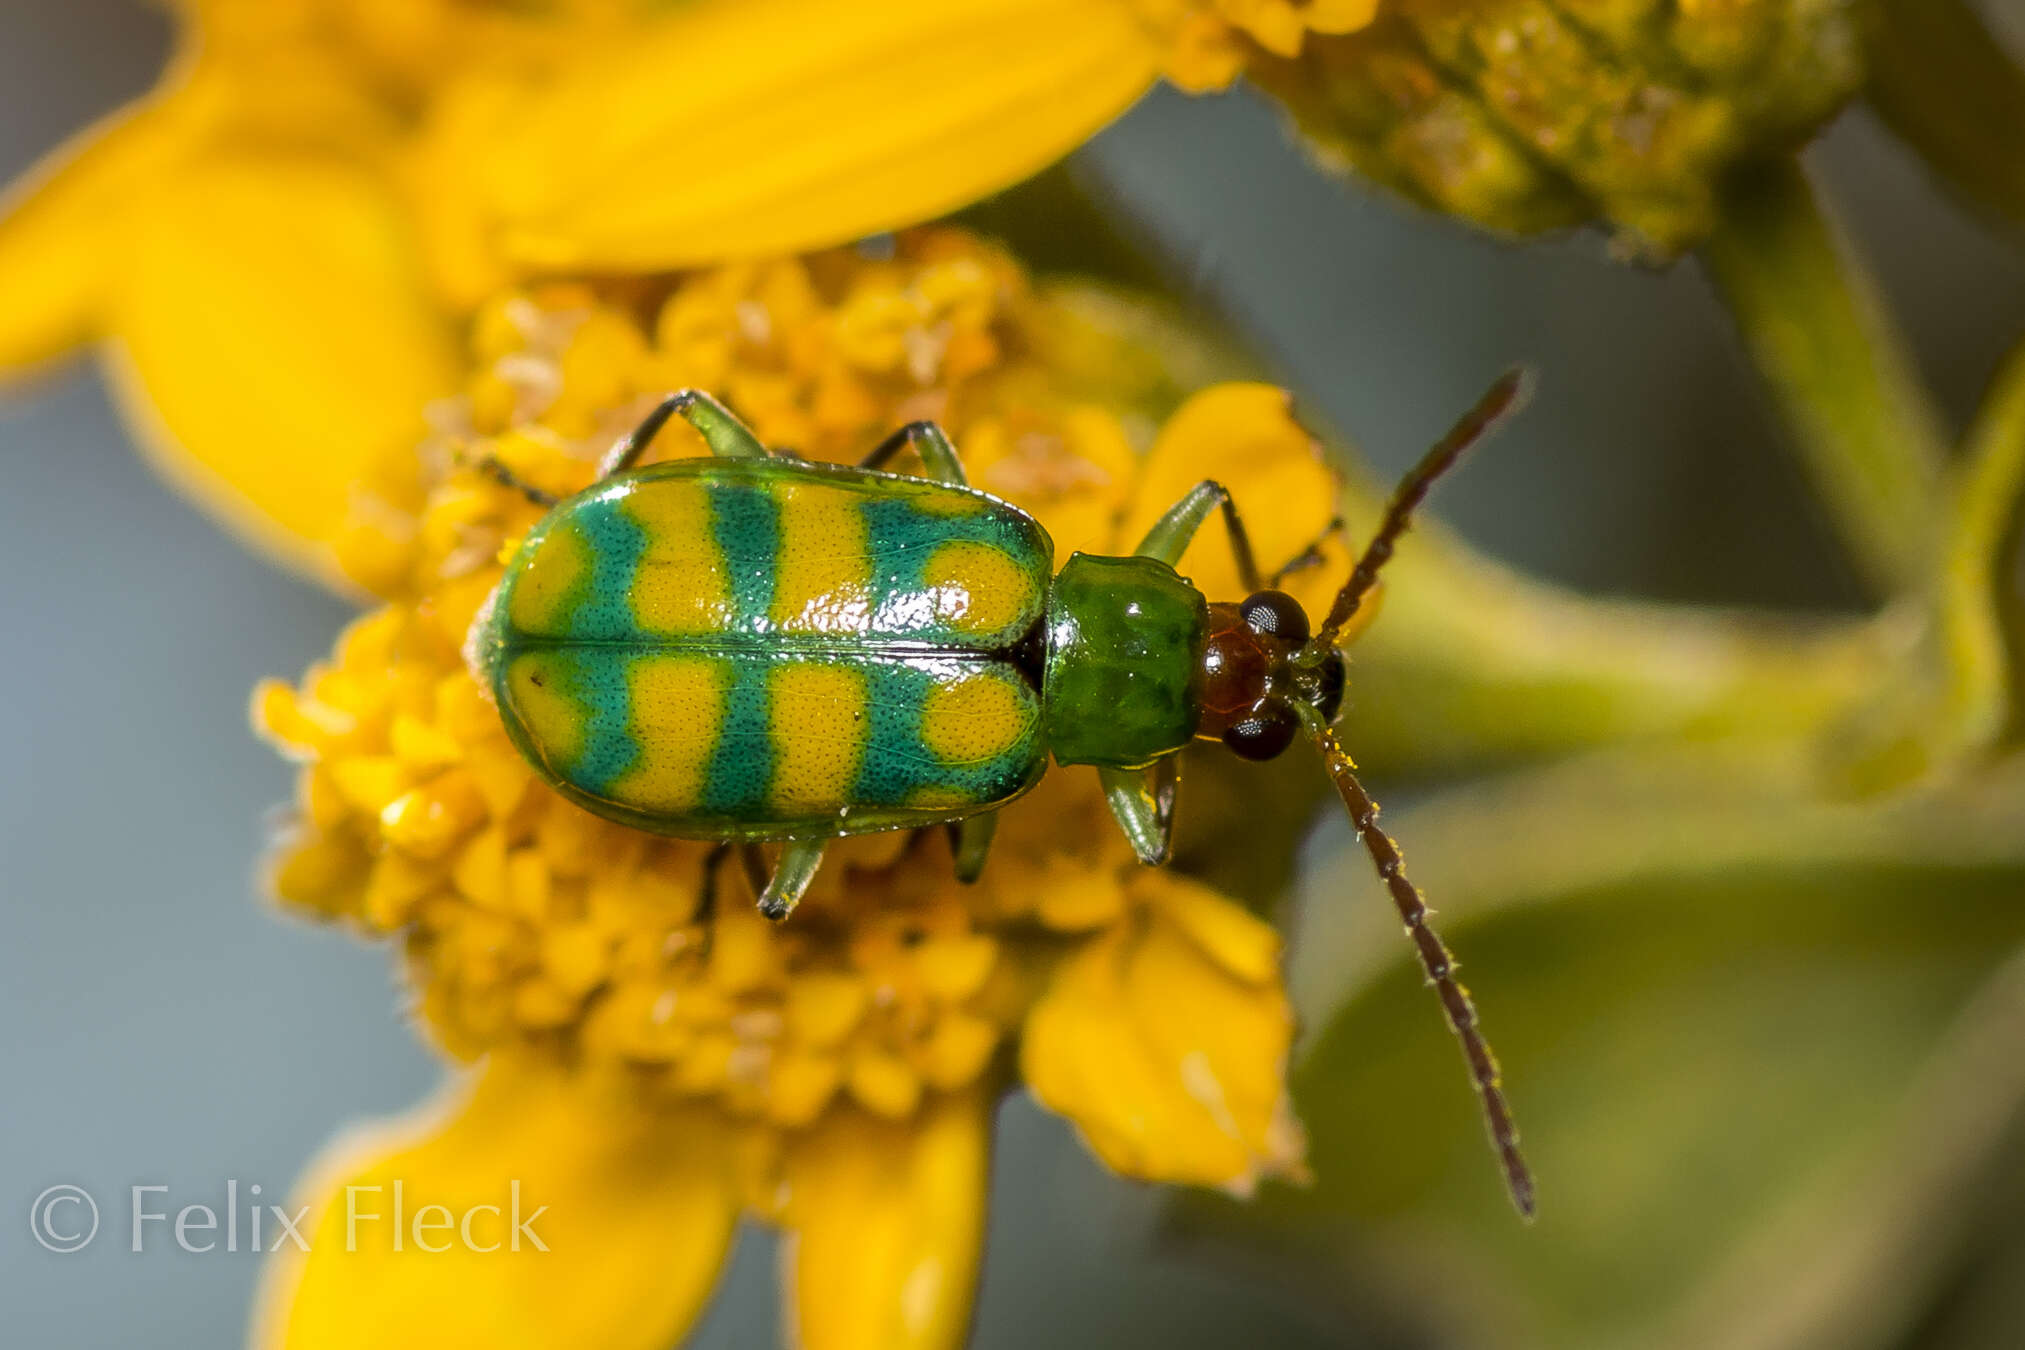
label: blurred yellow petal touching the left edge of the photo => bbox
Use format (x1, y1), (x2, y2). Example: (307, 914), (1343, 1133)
(0, 107), (168, 376)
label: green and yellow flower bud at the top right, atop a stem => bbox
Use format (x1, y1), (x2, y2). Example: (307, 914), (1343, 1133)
(1247, 0), (1867, 257)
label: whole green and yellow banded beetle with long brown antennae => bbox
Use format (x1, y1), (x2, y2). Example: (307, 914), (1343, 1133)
(466, 370), (1533, 1214)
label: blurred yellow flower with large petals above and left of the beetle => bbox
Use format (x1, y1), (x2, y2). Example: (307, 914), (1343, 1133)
(0, 0), (1375, 582)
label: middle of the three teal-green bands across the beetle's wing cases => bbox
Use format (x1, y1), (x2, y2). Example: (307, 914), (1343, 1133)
(703, 484), (780, 818)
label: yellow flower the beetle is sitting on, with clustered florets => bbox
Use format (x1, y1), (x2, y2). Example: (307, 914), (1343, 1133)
(255, 231), (1347, 1348)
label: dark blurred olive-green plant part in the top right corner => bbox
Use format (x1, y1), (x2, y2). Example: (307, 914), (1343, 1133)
(1867, 0), (2025, 238)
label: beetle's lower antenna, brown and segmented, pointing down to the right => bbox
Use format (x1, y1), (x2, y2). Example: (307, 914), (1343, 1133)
(1308, 716), (1533, 1218)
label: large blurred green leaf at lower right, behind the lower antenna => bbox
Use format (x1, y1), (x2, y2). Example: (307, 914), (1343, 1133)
(1175, 745), (2025, 1350)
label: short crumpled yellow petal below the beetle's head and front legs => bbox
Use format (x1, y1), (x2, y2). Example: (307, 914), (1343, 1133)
(1021, 882), (1306, 1194)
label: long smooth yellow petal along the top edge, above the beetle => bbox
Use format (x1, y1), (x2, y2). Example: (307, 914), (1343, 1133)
(451, 0), (1158, 269)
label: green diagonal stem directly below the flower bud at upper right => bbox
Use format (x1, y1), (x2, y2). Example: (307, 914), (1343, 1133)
(1703, 162), (1946, 595)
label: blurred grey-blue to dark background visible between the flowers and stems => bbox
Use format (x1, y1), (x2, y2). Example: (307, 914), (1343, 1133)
(0, 0), (2025, 1348)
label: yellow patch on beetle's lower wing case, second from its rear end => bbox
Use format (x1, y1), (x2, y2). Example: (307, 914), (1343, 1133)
(605, 656), (725, 816)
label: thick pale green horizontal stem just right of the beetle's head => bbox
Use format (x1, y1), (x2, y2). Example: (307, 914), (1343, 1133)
(1345, 505), (1887, 777)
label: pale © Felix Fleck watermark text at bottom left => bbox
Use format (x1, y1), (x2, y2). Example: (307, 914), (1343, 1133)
(28, 1180), (549, 1253)
